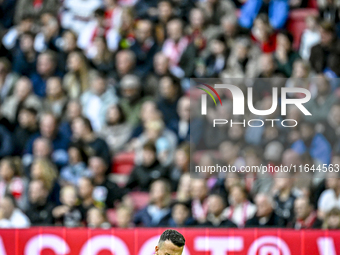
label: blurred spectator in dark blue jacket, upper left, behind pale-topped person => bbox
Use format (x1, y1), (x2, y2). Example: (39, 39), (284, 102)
(30, 50), (62, 97)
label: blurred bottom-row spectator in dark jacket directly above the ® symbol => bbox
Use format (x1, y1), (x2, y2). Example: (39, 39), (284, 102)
(245, 193), (283, 228)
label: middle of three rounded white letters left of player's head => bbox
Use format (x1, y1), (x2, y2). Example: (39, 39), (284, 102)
(80, 235), (130, 255)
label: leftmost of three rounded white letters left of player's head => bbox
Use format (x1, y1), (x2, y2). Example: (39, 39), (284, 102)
(24, 234), (70, 255)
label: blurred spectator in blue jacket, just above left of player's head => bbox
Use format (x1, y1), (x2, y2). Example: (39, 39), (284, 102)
(133, 179), (171, 227)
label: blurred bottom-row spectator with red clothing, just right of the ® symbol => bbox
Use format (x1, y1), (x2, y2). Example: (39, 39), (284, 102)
(292, 197), (322, 229)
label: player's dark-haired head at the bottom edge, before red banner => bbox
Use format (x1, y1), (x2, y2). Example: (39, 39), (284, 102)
(155, 229), (185, 255)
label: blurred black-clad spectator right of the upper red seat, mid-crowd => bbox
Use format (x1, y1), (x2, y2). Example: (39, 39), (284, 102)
(126, 142), (167, 191)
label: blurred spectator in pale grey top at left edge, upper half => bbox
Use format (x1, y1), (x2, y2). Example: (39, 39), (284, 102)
(1, 77), (42, 123)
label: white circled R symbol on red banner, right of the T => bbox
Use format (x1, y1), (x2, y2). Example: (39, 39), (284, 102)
(247, 236), (290, 255)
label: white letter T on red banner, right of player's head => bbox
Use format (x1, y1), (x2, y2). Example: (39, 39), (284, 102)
(194, 236), (243, 255)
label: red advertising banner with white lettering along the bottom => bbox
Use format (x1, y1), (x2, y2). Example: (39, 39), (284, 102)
(0, 228), (340, 255)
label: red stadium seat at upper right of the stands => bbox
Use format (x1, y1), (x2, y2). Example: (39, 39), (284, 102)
(287, 8), (318, 50)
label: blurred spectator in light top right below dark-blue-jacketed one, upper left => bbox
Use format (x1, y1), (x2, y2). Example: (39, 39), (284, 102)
(43, 77), (68, 118)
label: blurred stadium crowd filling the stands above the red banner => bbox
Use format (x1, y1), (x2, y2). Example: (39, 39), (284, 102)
(0, 0), (340, 229)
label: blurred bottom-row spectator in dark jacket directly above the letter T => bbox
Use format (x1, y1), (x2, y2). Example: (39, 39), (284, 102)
(200, 194), (237, 228)
